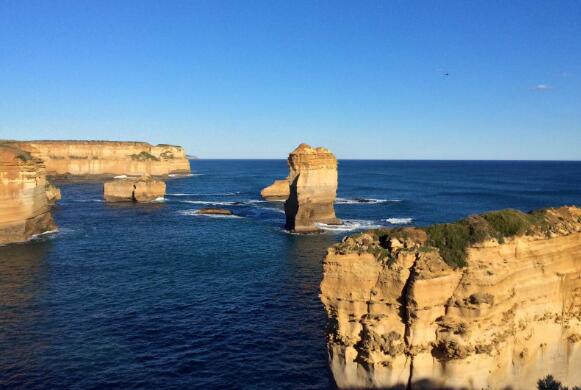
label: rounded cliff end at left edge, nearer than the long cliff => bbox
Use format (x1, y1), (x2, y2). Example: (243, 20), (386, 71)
(0, 145), (56, 244)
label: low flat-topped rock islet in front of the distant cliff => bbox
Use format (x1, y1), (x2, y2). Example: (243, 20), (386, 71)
(103, 176), (165, 202)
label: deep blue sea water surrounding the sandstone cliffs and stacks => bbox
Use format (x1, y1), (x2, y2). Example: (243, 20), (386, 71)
(0, 160), (581, 389)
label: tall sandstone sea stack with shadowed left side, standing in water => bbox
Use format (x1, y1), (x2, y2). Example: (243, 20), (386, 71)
(284, 144), (341, 233)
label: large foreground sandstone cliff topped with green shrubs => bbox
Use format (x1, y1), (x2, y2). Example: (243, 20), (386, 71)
(321, 207), (581, 389)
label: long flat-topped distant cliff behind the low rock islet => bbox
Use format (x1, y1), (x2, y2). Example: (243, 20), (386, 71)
(4, 141), (190, 176)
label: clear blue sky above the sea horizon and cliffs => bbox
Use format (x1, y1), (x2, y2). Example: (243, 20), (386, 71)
(0, 0), (581, 160)
